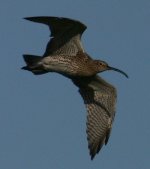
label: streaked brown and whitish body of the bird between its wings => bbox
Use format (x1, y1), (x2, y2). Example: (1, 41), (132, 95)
(25, 52), (109, 77)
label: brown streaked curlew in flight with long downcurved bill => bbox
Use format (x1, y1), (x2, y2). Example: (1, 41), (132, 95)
(22, 16), (128, 159)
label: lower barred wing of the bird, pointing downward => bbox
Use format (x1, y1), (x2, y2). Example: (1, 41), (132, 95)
(73, 76), (116, 159)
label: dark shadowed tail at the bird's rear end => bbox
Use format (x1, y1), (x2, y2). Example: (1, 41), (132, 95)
(22, 55), (47, 75)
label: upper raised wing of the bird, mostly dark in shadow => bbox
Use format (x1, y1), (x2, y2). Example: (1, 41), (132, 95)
(25, 16), (86, 57)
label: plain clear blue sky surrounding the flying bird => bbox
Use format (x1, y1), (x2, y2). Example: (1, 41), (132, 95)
(0, 0), (150, 169)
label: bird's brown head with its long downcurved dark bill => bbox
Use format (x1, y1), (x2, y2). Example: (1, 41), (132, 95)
(95, 60), (128, 78)
